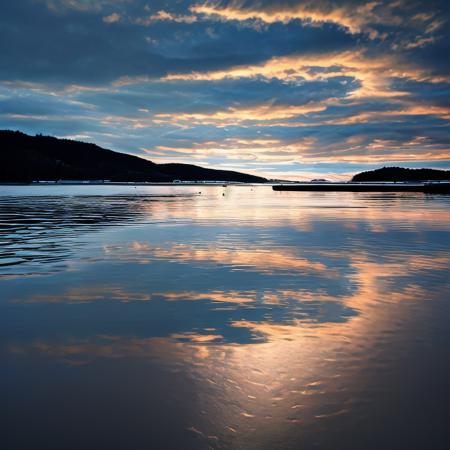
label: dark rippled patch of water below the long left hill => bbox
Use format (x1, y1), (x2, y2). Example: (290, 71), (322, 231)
(0, 195), (191, 276)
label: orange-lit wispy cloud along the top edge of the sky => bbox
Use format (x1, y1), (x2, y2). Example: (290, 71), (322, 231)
(190, 0), (445, 45)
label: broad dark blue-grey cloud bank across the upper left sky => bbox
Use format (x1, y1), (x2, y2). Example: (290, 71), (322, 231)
(0, 0), (362, 84)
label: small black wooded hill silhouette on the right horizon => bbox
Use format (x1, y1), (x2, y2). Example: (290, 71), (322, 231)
(352, 167), (450, 181)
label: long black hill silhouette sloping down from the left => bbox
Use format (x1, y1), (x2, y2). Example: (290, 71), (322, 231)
(0, 130), (267, 183)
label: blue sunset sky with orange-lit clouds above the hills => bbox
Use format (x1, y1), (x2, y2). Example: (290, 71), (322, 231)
(0, 0), (450, 180)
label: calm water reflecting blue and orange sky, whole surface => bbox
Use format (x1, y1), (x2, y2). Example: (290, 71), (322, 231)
(0, 186), (450, 450)
